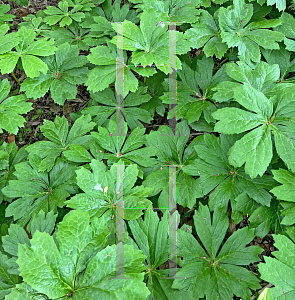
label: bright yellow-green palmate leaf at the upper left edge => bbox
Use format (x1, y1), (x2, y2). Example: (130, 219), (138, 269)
(0, 27), (56, 78)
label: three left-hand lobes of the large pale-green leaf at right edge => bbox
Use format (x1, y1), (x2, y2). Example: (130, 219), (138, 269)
(213, 83), (280, 179)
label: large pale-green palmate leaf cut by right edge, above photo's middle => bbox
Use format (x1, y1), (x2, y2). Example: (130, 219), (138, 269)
(212, 83), (295, 179)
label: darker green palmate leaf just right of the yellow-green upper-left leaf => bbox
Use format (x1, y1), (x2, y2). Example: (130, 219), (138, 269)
(20, 43), (89, 105)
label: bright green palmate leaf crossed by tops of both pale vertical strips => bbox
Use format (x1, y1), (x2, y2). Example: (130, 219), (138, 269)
(111, 9), (190, 74)
